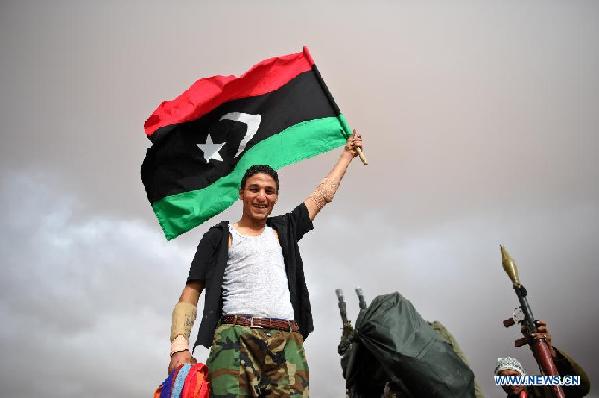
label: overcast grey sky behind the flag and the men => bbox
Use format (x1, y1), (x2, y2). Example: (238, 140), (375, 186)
(0, 0), (599, 398)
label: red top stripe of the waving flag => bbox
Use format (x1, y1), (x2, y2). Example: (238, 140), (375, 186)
(144, 47), (314, 136)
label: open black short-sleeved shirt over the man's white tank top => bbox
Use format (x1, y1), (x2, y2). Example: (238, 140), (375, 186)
(187, 203), (314, 348)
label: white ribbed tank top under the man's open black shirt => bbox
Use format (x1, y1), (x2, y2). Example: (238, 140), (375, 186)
(223, 224), (294, 320)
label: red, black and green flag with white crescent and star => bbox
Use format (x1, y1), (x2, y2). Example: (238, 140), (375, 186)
(141, 47), (349, 240)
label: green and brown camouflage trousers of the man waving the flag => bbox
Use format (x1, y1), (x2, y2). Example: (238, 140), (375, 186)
(206, 324), (309, 398)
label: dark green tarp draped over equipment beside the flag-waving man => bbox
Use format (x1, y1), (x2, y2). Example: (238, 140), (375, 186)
(342, 293), (474, 398)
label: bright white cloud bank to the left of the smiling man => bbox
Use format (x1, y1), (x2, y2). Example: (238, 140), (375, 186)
(0, 175), (193, 398)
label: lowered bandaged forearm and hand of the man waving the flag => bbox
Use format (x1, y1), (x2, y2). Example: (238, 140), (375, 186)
(168, 280), (204, 373)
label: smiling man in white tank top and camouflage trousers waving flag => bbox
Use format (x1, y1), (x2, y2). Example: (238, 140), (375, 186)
(169, 131), (362, 397)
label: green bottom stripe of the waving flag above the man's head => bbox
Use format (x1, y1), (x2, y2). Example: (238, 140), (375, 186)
(152, 115), (349, 240)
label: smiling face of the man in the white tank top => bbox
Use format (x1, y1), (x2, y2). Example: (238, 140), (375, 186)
(239, 173), (278, 221)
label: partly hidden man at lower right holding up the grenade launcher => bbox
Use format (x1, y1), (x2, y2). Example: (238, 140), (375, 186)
(495, 321), (591, 398)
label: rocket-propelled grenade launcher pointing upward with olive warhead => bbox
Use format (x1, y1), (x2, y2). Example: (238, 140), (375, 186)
(499, 245), (566, 398)
